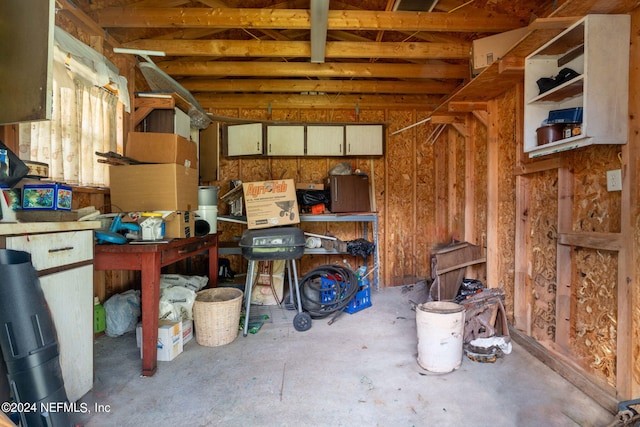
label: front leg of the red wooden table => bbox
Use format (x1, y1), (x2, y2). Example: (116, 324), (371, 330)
(141, 253), (161, 377)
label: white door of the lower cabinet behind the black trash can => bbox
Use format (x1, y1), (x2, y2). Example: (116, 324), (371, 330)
(40, 265), (93, 402)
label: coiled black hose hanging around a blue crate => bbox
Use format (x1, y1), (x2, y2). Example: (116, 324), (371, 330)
(299, 265), (358, 319)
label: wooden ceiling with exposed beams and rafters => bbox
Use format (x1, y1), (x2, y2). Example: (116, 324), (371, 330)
(58, 0), (565, 110)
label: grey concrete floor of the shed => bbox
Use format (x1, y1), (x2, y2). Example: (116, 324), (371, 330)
(77, 287), (613, 427)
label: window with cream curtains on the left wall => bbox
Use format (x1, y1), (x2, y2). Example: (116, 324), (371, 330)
(19, 28), (128, 187)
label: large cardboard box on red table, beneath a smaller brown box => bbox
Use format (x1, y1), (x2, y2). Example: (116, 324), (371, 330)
(109, 163), (198, 212)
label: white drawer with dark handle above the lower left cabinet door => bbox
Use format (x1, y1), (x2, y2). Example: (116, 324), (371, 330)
(6, 230), (93, 270)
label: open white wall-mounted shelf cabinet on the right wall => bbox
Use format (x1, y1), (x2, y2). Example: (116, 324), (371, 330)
(524, 15), (630, 157)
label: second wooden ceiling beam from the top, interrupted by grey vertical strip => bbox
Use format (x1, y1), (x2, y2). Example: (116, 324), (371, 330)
(123, 39), (471, 60)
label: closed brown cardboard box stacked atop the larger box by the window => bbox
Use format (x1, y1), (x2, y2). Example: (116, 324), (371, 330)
(125, 132), (198, 169)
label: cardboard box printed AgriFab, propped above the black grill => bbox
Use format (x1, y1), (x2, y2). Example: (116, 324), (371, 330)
(242, 179), (300, 229)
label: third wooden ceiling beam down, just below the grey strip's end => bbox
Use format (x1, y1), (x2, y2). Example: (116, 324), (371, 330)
(157, 61), (469, 79)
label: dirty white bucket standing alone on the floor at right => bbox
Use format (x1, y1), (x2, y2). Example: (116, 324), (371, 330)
(416, 301), (465, 373)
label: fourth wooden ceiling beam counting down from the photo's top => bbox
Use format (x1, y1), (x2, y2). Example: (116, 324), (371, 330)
(180, 79), (456, 95)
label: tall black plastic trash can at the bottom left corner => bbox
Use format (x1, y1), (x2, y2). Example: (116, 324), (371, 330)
(0, 249), (73, 427)
